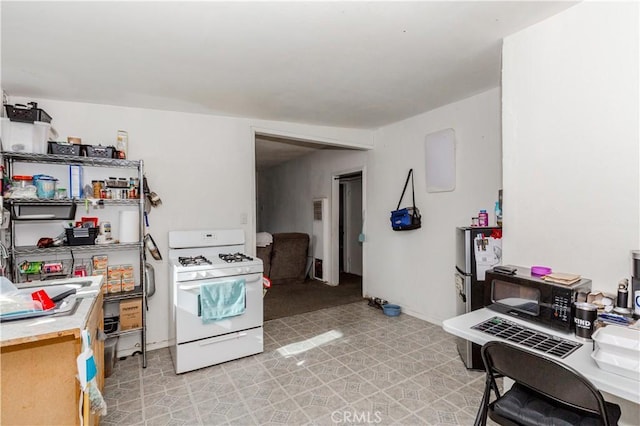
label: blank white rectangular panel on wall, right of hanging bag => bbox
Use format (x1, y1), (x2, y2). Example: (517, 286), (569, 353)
(425, 129), (456, 192)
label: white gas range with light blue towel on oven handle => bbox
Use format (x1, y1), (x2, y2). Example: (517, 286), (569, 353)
(169, 229), (264, 374)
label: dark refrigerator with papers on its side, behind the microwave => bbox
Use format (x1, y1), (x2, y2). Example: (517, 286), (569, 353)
(455, 227), (502, 370)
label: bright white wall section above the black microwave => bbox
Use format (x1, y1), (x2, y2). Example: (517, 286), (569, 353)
(502, 2), (640, 294)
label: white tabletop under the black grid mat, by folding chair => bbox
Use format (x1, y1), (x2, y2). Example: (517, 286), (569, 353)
(442, 308), (640, 404)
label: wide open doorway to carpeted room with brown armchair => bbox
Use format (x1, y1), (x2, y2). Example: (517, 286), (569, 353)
(255, 133), (366, 320)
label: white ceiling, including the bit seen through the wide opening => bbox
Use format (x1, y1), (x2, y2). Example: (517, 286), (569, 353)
(0, 1), (575, 166)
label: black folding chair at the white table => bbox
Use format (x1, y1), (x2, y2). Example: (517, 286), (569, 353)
(475, 341), (620, 426)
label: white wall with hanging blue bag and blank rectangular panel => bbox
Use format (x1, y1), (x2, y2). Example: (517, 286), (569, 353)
(364, 89), (502, 323)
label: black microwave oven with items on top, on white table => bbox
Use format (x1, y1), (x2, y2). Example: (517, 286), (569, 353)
(484, 266), (591, 332)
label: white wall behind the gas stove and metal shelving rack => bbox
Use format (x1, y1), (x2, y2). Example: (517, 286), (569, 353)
(9, 96), (372, 349)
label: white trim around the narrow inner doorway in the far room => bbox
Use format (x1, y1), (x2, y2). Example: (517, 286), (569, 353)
(329, 165), (367, 286)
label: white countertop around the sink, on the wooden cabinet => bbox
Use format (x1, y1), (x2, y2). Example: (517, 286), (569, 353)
(0, 276), (102, 347)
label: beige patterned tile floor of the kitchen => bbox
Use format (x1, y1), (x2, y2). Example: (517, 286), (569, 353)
(102, 302), (498, 426)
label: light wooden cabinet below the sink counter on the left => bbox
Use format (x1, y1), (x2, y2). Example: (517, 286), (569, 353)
(0, 294), (104, 425)
